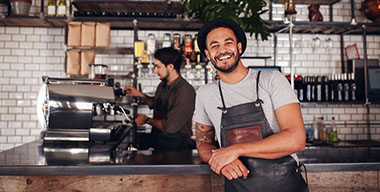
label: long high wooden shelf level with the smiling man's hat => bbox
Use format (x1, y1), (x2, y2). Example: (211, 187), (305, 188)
(0, 16), (380, 35)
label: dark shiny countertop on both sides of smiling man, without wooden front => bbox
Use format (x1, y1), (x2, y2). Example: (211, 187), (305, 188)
(0, 140), (380, 175)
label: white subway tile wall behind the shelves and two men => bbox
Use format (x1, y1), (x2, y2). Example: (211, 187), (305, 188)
(0, 0), (380, 151)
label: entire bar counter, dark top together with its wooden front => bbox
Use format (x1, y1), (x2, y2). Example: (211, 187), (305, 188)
(0, 140), (380, 191)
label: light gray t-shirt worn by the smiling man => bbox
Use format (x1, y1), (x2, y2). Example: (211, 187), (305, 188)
(193, 69), (299, 144)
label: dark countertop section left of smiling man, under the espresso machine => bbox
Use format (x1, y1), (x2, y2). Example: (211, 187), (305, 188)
(0, 140), (211, 175)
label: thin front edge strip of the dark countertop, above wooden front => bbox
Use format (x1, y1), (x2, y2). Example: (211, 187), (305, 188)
(0, 162), (380, 176)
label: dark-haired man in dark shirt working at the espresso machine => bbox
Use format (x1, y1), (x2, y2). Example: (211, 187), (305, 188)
(125, 48), (195, 150)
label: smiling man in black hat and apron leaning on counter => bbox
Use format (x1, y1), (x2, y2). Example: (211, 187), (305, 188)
(194, 19), (308, 192)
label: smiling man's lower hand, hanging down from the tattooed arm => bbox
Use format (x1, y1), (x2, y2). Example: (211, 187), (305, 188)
(221, 159), (249, 180)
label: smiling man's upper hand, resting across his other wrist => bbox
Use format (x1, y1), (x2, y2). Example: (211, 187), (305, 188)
(208, 145), (239, 174)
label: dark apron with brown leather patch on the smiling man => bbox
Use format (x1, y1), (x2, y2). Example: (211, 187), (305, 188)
(218, 71), (308, 192)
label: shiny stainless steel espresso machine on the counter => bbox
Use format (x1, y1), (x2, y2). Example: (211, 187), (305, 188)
(37, 76), (136, 146)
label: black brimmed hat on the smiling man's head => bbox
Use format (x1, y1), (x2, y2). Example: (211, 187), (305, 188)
(197, 18), (247, 55)
